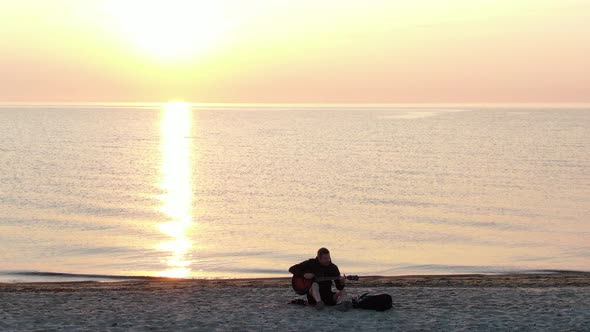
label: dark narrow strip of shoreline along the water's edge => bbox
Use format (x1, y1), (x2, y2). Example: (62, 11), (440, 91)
(0, 271), (590, 292)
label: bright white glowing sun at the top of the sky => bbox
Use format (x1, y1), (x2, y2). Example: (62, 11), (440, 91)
(107, 0), (229, 60)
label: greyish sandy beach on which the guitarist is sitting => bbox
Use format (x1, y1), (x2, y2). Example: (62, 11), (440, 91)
(0, 272), (590, 331)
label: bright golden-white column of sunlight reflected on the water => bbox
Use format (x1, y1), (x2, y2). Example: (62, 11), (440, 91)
(157, 102), (193, 278)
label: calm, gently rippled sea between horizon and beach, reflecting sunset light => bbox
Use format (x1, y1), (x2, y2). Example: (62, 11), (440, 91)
(0, 104), (590, 281)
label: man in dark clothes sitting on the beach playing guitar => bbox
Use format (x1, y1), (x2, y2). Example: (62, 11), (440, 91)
(289, 248), (352, 311)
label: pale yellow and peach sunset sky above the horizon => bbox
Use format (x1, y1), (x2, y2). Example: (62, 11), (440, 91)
(0, 0), (590, 103)
